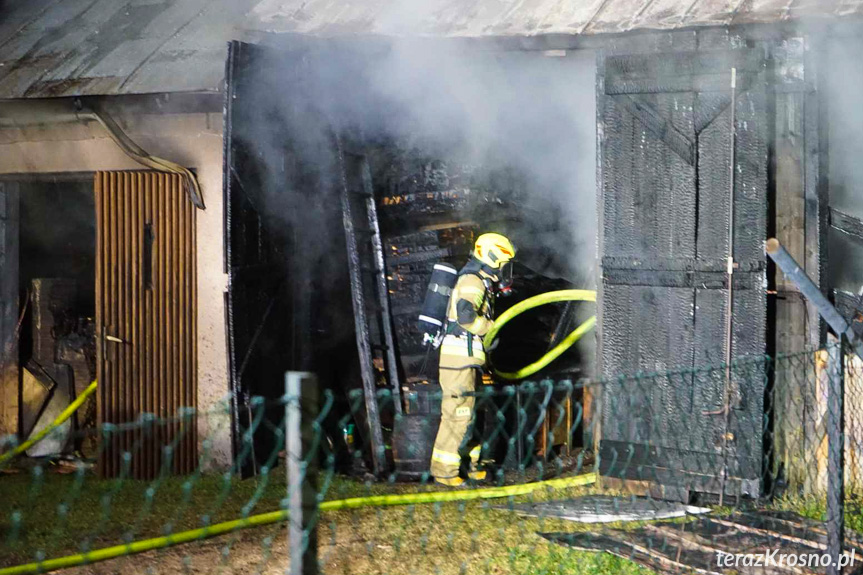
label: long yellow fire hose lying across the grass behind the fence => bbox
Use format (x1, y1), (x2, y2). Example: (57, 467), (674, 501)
(0, 473), (596, 575)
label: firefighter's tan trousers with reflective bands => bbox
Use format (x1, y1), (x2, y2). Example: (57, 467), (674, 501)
(431, 362), (480, 479)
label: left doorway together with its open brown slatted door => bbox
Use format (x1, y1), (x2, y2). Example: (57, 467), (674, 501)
(0, 171), (197, 478)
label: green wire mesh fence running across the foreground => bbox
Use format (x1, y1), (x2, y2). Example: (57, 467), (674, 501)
(0, 347), (863, 575)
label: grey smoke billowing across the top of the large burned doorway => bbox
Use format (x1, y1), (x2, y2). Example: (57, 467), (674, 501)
(242, 40), (596, 287)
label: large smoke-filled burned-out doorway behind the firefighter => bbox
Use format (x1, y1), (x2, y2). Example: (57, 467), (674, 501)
(225, 38), (595, 473)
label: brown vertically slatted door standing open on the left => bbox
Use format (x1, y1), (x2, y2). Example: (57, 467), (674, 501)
(95, 172), (197, 478)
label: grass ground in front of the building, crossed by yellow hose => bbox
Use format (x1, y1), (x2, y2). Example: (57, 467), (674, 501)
(0, 470), (648, 575)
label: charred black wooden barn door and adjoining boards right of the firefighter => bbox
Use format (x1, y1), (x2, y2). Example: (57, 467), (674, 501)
(598, 29), (830, 498)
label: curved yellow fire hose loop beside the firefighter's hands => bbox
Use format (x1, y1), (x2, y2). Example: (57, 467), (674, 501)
(483, 290), (596, 379)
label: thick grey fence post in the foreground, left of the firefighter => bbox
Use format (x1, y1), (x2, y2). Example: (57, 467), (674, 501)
(285, 371), (319, 575)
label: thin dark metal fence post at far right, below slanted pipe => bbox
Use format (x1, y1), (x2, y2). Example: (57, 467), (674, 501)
(827, 342), (845, 575)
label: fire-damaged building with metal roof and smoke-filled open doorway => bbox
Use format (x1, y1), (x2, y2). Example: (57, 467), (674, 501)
(0, 0), (863, 495)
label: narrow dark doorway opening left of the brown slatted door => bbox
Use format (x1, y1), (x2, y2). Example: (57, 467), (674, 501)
(17, 174), (96, 457)
